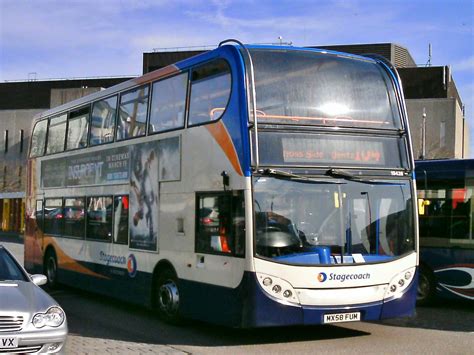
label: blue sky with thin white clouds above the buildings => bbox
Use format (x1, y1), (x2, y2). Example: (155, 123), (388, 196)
(0, 0), (474, 157)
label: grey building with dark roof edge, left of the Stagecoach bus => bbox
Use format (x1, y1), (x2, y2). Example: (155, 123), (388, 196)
(0, 78), (130, 235)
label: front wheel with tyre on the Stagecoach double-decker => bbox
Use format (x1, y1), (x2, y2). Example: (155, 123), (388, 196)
(154, 269), (181, 324)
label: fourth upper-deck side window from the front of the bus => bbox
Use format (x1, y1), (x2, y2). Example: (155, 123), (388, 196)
(89, 96), (117, 145)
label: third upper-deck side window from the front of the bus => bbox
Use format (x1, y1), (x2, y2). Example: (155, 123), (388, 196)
(116, 85), (149, 140)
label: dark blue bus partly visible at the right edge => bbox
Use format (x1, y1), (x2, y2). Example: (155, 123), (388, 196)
(415, 159), (474, 305)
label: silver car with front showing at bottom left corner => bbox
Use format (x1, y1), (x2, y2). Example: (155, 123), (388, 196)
(0, 245), (68, 354)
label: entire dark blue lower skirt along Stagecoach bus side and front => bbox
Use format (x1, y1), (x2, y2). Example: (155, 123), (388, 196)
(50, 263), (417, 328)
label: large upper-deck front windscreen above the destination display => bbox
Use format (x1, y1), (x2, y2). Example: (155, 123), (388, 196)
(251, 50), (401, 129)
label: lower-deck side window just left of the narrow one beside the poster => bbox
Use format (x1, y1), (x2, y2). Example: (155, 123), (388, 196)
(86, 196), (113, 242)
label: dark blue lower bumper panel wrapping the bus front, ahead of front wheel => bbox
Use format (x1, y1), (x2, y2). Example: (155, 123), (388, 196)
(180, 272), (417, 327)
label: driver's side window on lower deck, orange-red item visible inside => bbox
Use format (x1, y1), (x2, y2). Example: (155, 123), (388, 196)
(195, 191), (245, 256)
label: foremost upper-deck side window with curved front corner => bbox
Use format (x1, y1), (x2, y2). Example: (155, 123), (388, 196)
(189, 59), (231, 125)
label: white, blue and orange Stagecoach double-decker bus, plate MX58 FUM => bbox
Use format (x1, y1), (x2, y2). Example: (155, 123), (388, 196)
(25, 40), (418, 327)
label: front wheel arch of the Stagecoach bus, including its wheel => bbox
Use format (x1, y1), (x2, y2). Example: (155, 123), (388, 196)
(151, 260), (181, 324)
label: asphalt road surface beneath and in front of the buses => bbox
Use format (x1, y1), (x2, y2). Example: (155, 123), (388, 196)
(1, 242), (474, 355)
